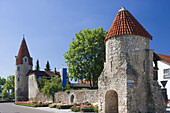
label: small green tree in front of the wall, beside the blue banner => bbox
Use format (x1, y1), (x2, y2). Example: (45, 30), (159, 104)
(41, 76), (62, 102)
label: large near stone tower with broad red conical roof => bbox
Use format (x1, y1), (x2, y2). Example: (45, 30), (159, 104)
(98, 7), (165, 113)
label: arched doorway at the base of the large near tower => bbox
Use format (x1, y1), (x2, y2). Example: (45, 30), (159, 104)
(105, 90), (118, 113)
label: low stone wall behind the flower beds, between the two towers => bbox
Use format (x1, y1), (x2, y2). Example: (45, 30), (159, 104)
(29, 90), (98, 104)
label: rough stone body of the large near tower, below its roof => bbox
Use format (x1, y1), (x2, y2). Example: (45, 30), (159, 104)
(98, 35), (149, 113)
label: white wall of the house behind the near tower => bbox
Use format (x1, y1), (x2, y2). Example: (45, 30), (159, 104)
(158, 61), (170, 99)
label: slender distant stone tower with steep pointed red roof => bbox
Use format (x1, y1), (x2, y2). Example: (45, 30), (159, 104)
(15, 38), (33, 101)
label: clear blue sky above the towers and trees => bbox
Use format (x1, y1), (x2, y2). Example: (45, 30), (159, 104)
(0, 0), (170, 78)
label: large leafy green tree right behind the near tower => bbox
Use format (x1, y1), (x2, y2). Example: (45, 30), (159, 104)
(64, 27), (108, 88)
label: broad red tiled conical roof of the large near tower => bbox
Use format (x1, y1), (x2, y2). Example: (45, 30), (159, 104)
(105, 7), (152, 42)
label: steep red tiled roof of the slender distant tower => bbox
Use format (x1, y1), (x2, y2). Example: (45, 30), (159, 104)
(16, 38), (33, 65)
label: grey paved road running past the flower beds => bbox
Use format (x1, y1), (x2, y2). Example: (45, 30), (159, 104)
(0, 103), (170, 113)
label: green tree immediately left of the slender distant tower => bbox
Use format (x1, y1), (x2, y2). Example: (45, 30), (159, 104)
(2, 75), (15, 98)
